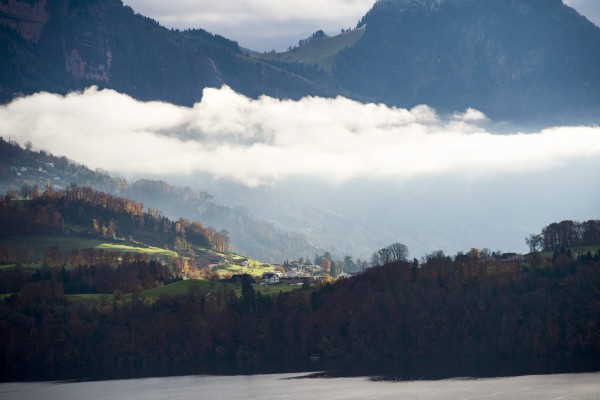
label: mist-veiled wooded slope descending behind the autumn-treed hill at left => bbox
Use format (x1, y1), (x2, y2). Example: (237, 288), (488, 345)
(0, 138), (315, 262)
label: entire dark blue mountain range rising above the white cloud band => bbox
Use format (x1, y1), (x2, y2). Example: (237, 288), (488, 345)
(0, 0), (600, 124)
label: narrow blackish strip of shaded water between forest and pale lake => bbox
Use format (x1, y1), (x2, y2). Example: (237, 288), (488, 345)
(5, 357), (600, 382)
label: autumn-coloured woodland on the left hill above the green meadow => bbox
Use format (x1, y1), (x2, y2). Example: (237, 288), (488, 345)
(0, 184), (229, 252)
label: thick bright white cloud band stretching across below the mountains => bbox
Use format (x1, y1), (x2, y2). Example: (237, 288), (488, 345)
(0, 87), (600, 185)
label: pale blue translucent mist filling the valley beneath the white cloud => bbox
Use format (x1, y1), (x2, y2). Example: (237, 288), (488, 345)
(195, 159), (600, 259)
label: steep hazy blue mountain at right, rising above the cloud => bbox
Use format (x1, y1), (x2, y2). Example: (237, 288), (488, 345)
(334, 0), (600, 122)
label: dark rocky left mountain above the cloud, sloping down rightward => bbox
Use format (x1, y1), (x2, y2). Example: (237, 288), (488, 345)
(0, 0), (326, 105)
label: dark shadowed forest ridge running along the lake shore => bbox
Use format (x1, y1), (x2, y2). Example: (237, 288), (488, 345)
(0, 222), (600, 377)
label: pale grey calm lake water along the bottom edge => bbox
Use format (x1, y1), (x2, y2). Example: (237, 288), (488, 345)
(0, 373), (600, 400)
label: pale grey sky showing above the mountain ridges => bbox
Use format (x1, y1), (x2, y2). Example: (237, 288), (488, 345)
(124, 0), (600, 51)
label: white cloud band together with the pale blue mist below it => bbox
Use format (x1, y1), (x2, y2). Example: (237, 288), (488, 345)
(0, 88), (600, 258)
